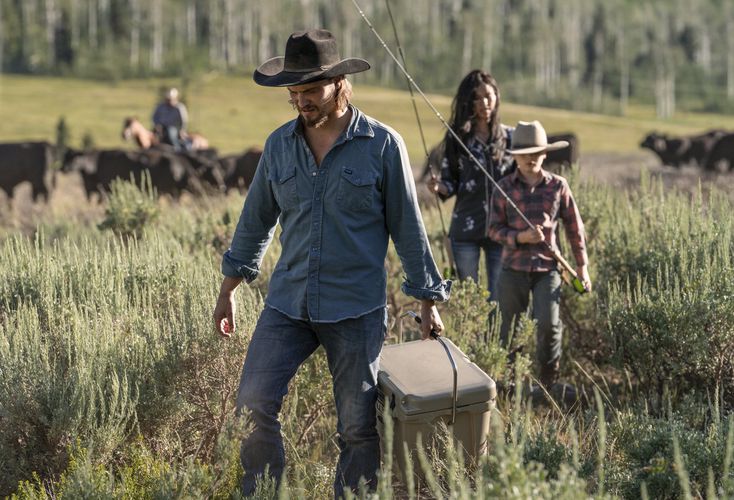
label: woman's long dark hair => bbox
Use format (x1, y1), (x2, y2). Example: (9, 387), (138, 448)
(444, 69), (505, 171)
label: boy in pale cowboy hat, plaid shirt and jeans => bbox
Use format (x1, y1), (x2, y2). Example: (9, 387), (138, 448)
(489, 120), (591, 390)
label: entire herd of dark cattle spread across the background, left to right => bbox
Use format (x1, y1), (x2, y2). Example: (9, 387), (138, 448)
(0, 129), (734, 206)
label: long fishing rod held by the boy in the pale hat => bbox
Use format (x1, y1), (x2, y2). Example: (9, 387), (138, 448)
(352, 0), (588, 293)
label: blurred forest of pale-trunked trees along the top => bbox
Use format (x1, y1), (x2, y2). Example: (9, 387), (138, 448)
(0, 0), (734, 117)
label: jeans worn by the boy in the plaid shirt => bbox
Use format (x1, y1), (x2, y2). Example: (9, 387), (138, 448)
(498, 268), (563, 387)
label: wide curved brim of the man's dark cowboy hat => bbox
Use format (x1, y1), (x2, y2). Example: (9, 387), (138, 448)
(252, 57), (370, 87)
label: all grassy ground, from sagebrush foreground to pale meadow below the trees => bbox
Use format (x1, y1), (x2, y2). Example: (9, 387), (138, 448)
(0, 75), (734, 500)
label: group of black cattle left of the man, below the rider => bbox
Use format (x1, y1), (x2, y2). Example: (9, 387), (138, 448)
(0, 142), (262, 201)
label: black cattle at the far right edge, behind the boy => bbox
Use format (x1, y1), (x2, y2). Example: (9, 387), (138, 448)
(640, 129), (734, 172)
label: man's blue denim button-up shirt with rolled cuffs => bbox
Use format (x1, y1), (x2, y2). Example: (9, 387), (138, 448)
(222, 106), (451, 323)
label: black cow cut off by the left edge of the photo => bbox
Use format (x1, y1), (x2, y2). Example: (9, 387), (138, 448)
(0, 141), (56, 201)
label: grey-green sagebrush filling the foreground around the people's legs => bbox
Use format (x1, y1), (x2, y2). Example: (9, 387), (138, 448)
(0, 169), (734, 499)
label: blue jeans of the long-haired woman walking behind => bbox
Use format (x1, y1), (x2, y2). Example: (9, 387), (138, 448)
(451, 238), (502, 301)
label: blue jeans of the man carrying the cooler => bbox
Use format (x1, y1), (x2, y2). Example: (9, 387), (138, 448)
(237, 307), (387, 498)
